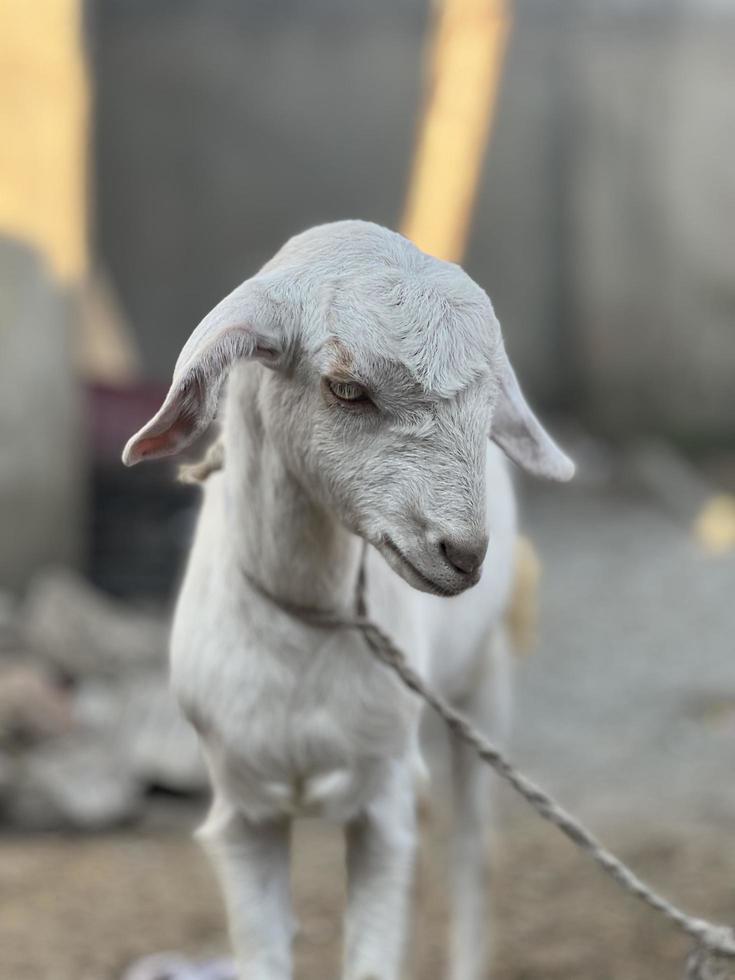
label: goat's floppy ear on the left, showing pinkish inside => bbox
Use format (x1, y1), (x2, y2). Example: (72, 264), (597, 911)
(122, 280), (283, 466)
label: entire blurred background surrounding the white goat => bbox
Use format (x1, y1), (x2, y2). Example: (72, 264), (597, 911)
(0, 0), (735, 980)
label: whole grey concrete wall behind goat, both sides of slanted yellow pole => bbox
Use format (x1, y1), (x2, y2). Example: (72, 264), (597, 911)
(90, 0), (735, 440)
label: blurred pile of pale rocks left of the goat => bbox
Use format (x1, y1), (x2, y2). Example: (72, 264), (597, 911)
(0, 570), (206, 830)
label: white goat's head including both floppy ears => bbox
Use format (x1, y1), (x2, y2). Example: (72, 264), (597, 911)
(123, 221), (573, 594)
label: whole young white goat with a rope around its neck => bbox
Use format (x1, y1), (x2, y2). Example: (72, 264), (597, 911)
(123, 221), (574, 980)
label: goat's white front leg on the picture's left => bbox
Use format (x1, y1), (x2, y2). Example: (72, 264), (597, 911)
(197, 799), (294, 980)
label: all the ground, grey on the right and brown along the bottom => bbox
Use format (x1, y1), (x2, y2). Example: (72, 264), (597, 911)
(0, 470), (735, 980)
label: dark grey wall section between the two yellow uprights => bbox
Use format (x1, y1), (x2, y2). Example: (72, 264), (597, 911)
(93, 0), (425, 376)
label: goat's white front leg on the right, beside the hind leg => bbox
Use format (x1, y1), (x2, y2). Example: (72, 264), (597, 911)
(342, 762), (416, 980)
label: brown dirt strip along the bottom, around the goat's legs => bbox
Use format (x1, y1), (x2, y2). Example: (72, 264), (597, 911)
(0, 813), (735, 980)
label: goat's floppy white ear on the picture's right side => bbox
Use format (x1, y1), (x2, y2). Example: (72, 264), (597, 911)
(490, 350), (575, 482)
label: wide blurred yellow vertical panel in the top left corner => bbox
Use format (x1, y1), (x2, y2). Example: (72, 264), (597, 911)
(0, 0), (89, 283)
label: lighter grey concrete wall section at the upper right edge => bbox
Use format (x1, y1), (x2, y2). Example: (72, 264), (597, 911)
(563, 18), (735, 442)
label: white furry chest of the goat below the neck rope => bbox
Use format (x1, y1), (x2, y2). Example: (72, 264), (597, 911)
(171, 610), (418, 820)
